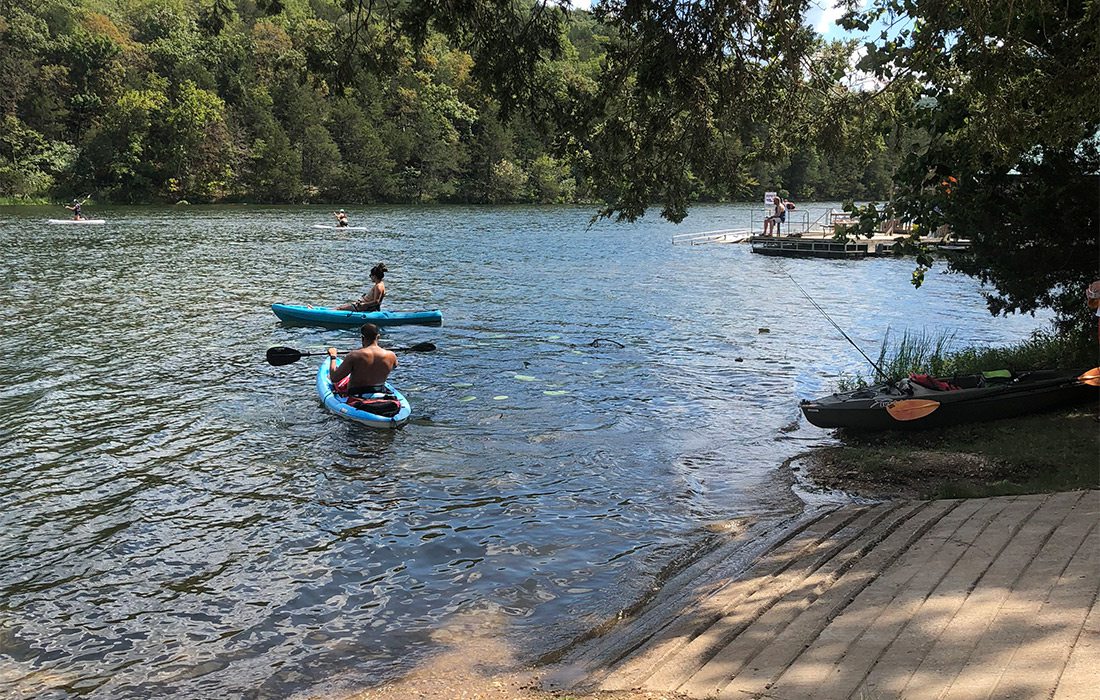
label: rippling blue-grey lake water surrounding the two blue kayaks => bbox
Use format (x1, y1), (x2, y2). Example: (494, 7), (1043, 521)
(0, 204), (1044, 699)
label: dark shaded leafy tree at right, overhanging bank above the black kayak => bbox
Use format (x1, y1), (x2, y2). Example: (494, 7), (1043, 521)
(846, 0), (1100, 321)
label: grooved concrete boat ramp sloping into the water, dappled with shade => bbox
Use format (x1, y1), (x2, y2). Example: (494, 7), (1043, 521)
(543, 491), (1100, 700)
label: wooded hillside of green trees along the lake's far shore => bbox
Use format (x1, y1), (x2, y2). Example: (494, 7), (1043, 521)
(0, 0), (900, 204)
